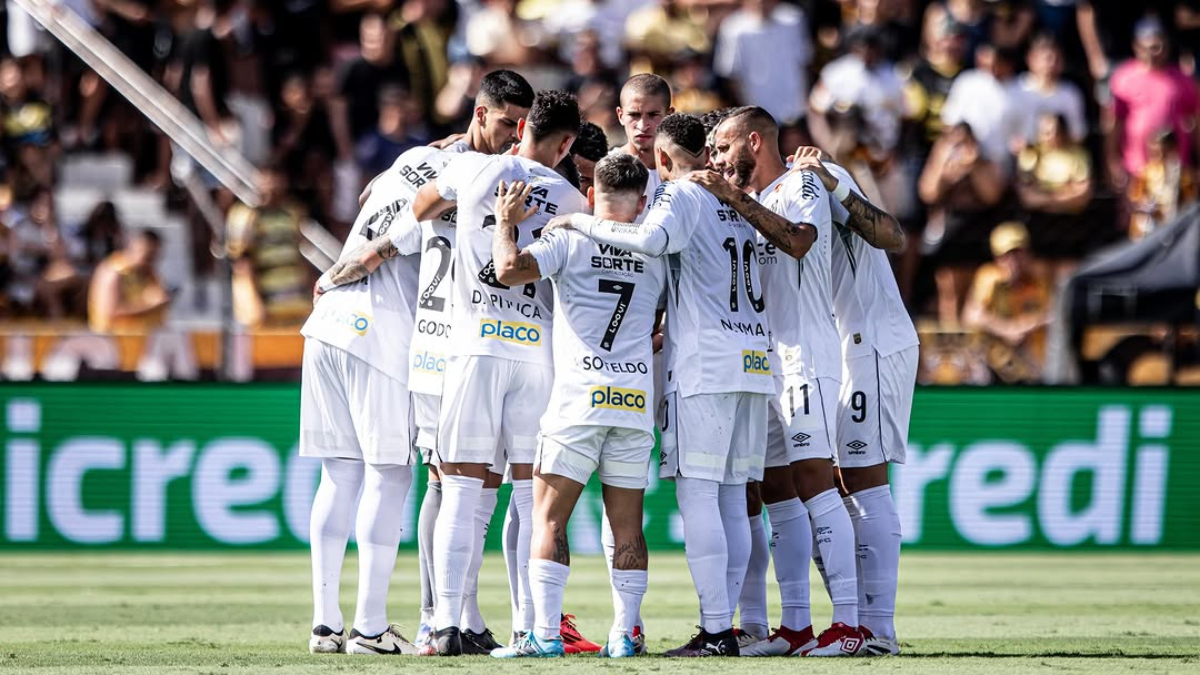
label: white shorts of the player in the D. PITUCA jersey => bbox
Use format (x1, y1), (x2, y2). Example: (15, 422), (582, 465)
(433, 356), (554, 473)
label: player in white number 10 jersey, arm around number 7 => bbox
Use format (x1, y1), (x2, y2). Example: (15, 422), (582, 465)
(554, 114), (806, 656)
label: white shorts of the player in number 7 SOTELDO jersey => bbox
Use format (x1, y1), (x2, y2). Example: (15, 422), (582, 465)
(535, 424), (654, 490)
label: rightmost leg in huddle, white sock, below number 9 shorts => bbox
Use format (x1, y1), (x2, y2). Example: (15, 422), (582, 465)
(841, 464), (900, 656)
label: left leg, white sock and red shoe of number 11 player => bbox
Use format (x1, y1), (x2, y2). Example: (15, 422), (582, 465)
(742, 466), (816, 656)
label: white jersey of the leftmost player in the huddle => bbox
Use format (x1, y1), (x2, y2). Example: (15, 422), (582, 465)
(300, 148), (442, 383)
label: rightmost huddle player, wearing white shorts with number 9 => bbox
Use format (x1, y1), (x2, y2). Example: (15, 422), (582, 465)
(794, 148), (919, 656)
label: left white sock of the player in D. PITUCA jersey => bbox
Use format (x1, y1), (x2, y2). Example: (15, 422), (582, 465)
(433, 476), (484, 629)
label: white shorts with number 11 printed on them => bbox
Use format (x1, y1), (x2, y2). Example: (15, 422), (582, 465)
(767, 375), (838, 467)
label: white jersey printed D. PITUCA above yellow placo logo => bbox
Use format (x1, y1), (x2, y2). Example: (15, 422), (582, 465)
(437, 153), (587, 366)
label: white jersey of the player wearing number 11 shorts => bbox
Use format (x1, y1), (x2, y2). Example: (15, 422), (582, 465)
(758, 171), (841, 380)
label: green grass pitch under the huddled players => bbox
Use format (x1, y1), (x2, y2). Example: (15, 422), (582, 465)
(0, 552), (1200, 675)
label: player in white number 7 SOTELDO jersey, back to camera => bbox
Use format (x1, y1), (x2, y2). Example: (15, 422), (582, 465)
(492, 155), (666, 658)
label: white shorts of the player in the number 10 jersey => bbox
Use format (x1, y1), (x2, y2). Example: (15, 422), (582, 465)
(659, 392), (770, 485)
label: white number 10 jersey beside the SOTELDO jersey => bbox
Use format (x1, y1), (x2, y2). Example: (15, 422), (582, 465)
(646, 180), (774, 396)
